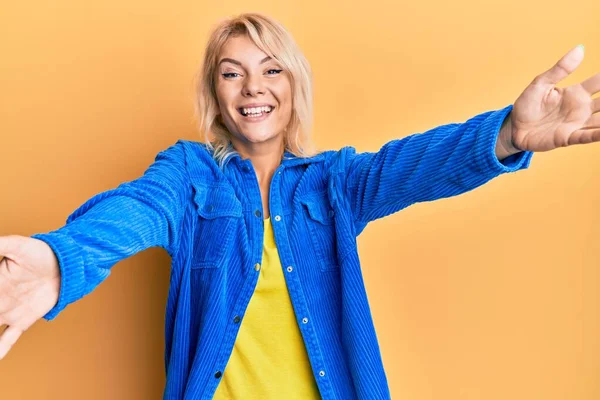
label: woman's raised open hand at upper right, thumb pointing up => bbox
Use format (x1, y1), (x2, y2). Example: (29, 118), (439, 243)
(509, 46), (600, 152)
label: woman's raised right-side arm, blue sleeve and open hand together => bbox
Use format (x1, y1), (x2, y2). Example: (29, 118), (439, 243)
(342, 46), (600, 232)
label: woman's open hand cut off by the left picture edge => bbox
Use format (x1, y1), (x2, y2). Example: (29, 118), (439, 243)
(0, 235), (60, 360)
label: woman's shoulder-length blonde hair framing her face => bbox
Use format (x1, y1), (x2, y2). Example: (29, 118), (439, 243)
(195, 13), (316, 168)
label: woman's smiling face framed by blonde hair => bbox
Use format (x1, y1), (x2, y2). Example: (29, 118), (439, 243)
(215, 36), (292, 147)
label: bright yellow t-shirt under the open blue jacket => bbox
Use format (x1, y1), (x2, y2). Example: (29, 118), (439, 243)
(213, 218), (321, 400)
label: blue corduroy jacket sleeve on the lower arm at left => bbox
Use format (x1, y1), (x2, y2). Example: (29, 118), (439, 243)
(31, 141), (191, 321)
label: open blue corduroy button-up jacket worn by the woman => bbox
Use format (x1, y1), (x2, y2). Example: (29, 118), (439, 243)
(32, 105), (532, 400)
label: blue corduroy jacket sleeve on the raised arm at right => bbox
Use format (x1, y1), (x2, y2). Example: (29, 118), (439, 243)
(343, 105), (533, 233)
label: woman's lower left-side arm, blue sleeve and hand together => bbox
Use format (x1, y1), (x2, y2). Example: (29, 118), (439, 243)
(0, 142), (191, 360)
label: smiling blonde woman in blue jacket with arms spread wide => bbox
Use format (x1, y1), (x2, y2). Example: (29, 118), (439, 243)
(0, 14), (600, 400)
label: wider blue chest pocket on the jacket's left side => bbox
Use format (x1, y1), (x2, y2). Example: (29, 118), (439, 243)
(191, 184), (242, 269)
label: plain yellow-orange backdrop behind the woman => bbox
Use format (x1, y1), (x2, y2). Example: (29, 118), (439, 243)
(0, 0), (600, 400)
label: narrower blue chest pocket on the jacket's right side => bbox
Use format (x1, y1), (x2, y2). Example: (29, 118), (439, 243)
(300, 193), (339, 271)
